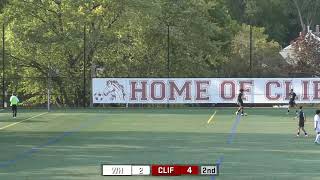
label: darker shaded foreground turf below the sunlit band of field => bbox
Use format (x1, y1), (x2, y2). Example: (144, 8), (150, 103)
(0, 131), (320, 179)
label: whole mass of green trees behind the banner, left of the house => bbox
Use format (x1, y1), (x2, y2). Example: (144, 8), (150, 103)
(0, 0), (319, 106)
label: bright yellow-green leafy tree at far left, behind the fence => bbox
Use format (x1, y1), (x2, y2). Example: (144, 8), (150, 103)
(2, 0), (130, 105)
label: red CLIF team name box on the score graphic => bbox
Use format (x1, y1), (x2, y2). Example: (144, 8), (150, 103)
(151, 165), (181, 176)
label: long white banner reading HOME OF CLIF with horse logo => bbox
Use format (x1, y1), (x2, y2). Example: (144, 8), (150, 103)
(92, 78), (320, 104)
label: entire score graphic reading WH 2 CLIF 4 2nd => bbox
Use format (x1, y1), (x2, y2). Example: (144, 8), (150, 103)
(101, 164), (219, 176)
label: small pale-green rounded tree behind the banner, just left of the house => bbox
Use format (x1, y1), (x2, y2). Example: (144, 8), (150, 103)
(223, 24), (285, 77)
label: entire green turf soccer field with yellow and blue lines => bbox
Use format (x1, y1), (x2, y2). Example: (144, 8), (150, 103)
(0, 108), (320, 180)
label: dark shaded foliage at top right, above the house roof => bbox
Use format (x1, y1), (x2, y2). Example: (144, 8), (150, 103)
(226, 0), (320, 47)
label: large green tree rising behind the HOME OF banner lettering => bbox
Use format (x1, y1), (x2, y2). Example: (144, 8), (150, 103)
(93, 0), (236, 77)
